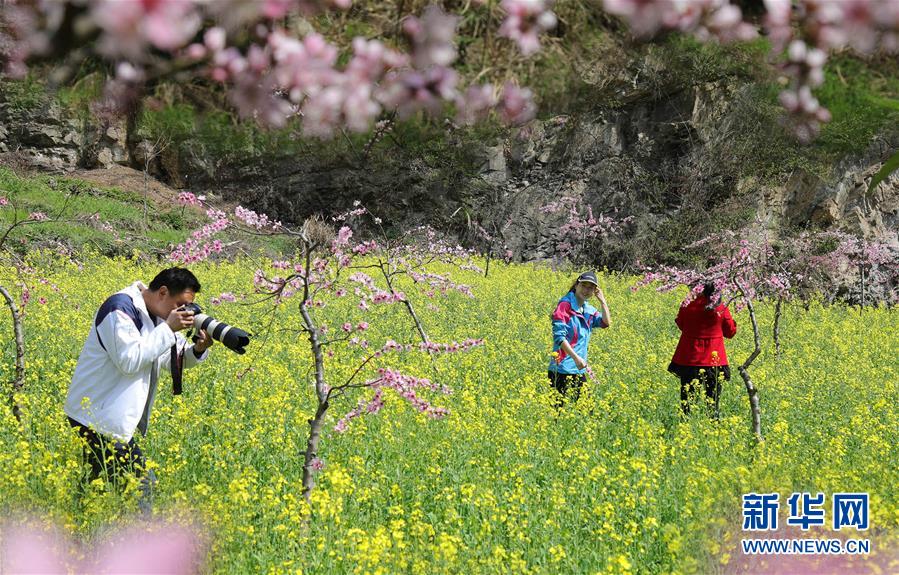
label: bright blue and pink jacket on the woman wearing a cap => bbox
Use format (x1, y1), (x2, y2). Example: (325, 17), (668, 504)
(549, 292), (602, 374)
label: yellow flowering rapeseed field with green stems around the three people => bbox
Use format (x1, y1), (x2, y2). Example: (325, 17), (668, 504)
(0, 254), (899, 574)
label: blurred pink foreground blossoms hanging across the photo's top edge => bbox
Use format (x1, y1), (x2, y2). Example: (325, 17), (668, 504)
(7, 0), (899, 141)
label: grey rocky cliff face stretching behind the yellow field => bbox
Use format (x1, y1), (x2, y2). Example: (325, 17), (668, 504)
(0, 83), (899, 268)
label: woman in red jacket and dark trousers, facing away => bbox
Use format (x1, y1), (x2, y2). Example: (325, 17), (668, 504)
(668, 283), (737, 419)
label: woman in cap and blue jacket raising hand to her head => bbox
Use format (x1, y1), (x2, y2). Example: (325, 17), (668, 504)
(549, 272), (611, 406)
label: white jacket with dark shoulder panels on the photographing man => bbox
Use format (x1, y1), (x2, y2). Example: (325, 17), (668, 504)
(64, 282), (208, 442)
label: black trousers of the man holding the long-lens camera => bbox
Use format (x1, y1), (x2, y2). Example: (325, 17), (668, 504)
(68, 417), (156, 515)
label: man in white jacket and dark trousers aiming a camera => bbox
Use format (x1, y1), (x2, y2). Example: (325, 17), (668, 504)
(64, 268), (212, 514)
